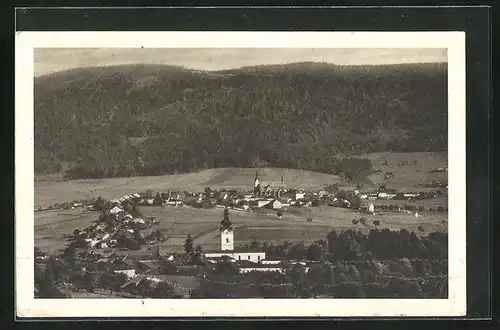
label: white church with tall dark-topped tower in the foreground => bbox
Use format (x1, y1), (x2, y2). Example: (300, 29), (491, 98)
(205, 208), (266, 263)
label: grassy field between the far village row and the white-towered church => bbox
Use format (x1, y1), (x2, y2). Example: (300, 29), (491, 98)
(35, 206), (447, 254)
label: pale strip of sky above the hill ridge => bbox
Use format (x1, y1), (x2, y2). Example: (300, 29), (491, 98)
(35, 48), (447, 76)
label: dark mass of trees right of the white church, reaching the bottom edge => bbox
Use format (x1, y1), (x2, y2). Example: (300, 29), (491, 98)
(193, 229), (448, 299)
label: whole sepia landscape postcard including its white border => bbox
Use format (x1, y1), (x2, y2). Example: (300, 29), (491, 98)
(16, 32), (465, 316)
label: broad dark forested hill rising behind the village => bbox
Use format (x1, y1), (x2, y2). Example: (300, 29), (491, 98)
(35, 63), (447, 178)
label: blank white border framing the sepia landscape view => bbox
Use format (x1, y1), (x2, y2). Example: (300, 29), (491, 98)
(15, 32), (466, 317)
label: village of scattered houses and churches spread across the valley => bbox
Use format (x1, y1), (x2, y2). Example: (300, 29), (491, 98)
(35, 173), (447, 298)
